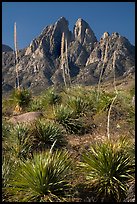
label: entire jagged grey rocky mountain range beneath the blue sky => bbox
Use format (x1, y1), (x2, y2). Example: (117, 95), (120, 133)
(2, 17), (135, 93)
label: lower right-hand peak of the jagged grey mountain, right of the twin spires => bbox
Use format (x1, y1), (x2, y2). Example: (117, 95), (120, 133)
(77, 32), (135, 83)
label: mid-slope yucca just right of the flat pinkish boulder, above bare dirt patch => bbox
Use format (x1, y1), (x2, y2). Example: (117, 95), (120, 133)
(54, 105), (85, 134)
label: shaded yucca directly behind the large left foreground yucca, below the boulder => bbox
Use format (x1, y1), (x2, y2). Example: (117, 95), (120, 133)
(33, 120), (65, 149)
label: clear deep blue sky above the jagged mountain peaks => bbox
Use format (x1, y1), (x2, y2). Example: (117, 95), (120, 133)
(2, 2), (135, 49)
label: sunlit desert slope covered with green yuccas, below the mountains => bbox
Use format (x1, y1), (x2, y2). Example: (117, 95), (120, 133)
(2, 80), (135, 202)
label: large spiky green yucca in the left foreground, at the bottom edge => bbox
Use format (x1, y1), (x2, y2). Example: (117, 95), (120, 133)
(6, 150), (72, 202)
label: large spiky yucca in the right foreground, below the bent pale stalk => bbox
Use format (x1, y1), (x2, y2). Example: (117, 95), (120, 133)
(80, 139), (134, 202)
